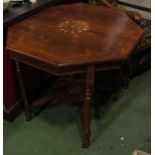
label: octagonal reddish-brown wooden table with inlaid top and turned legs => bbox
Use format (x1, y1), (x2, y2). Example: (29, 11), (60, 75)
(7, 3), (143, 147)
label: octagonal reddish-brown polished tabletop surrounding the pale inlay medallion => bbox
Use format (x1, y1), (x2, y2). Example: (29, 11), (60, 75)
(7, 4), (143, 75)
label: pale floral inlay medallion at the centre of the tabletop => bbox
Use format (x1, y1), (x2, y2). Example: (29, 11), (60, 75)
(59, 20), (89, 34)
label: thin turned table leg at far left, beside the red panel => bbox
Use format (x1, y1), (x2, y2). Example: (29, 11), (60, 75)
(15, 61), (32, 121)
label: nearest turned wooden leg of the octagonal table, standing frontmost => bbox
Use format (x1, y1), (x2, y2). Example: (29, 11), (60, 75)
(81, 66), (95, 148)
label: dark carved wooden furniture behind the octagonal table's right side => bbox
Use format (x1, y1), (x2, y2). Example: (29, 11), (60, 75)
(100, 0), (151, 77)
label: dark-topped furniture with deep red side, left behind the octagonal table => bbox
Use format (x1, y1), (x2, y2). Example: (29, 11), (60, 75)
(3, 0), (55, 121)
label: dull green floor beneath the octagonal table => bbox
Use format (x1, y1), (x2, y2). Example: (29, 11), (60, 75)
(4, 71), (151, 155)
